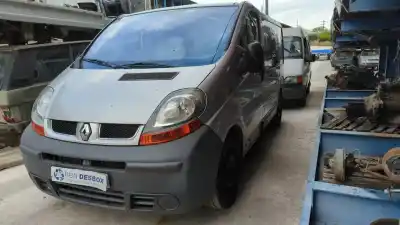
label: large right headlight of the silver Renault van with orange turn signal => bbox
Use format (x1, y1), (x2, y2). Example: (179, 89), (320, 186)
(140, 89), (207, 145)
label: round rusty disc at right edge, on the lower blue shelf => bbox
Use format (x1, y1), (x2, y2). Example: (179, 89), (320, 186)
(382, 148), (400, 184)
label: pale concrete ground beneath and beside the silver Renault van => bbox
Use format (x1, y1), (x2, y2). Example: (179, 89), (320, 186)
(0, 61), (331, 225)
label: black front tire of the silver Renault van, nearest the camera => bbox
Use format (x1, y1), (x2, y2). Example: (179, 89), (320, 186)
(209, 135), (243, 210)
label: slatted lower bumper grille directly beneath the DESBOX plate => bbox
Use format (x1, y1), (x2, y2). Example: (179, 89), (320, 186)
(55, 184), (125, 209)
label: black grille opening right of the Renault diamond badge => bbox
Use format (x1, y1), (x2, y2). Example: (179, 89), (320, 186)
(100, 123), (139, 138)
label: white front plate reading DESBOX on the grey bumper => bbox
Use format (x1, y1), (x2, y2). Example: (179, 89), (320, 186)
(51, 166), (108, 191)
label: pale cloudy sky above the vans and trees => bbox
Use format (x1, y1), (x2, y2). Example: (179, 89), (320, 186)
(194, 0), (334, 30)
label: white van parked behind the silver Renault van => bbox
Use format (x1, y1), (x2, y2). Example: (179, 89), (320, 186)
(282, 27), (316, 106)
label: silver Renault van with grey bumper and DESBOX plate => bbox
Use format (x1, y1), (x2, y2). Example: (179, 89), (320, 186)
(20, 2), (283, 213)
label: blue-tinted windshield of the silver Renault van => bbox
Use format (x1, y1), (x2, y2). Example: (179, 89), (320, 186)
(81, 6), (238, 69)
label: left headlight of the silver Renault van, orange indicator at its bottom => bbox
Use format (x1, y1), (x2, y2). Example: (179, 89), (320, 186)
(31, 86), (54, 135)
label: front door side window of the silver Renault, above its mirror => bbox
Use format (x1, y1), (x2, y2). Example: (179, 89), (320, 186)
(240, 12), (260, 47)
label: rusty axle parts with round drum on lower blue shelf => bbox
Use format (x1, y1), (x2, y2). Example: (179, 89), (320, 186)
(320, 148), (400, 191)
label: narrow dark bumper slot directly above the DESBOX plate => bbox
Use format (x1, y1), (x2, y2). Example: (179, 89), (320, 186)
(42, 153), (126, 170)
